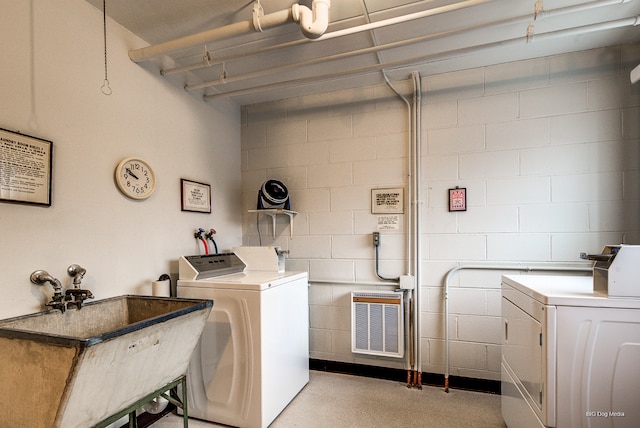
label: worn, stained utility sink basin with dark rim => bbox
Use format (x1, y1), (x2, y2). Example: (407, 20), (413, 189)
(0, 296), (213, 428)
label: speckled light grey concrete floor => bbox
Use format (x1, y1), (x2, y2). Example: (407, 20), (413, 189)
(153, 371), (505, 428)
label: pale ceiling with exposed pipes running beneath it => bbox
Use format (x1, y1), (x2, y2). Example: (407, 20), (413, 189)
(86, 0), (640, 105)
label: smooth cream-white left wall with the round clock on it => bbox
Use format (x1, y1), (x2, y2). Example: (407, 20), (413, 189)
(0, 0), (241, 317)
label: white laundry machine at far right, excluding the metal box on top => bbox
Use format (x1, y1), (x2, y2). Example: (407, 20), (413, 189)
(502, 275), (640, 428)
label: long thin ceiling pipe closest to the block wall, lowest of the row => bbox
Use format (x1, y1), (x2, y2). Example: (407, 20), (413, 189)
(204, 16), (640, 100)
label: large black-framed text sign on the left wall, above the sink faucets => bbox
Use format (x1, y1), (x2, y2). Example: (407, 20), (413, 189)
(0, 128), (53, 207)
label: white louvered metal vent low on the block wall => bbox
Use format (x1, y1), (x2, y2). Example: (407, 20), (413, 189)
(351, 291), (404, 358)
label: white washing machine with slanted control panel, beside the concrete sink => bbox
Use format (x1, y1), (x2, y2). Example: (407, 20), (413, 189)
(177, 247), (309, 428)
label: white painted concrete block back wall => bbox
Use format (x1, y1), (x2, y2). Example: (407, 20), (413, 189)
(242, 45), (640, 379)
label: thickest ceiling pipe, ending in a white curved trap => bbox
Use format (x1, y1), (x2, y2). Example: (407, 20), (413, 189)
(129, 0), (331, 62)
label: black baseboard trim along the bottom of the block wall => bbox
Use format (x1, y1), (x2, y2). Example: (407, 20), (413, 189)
(309, 358), (500, 394)
